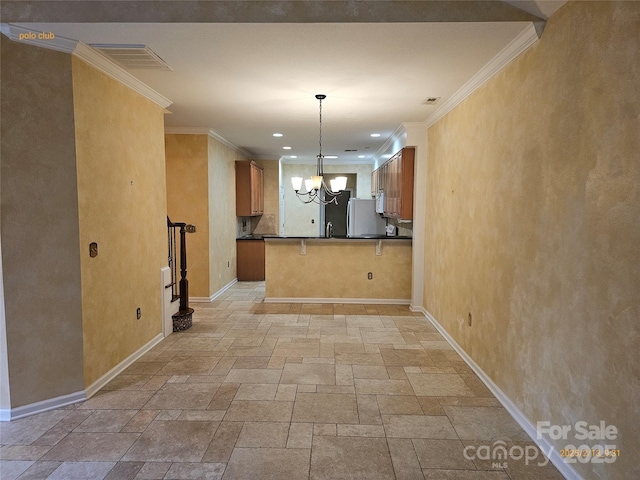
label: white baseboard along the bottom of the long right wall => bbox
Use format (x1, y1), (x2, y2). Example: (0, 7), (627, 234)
(420, 307), (584, 480)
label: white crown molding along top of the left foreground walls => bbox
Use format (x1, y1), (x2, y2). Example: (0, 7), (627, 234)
(0, 23), (173, 108)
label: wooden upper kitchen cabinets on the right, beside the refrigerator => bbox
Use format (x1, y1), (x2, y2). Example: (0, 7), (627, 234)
(372, 147), (415, 220)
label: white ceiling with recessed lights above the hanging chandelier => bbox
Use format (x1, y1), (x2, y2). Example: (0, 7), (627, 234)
(15, 1), (563, 163)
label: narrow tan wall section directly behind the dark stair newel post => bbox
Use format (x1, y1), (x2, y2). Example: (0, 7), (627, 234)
(165, 135), (210, 298)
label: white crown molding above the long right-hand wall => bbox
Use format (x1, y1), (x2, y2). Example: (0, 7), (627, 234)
(425, 23), (541, 128)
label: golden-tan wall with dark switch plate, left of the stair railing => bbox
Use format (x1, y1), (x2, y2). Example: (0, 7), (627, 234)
(72, 57), (167, 386)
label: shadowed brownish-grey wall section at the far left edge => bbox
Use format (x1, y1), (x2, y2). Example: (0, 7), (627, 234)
(0, 35), (88, 408)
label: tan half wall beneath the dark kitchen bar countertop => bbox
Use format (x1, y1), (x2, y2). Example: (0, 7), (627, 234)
(265, 240), (411, 300)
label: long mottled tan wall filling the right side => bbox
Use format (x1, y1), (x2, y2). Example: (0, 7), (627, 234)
(424, 2), (640, 479)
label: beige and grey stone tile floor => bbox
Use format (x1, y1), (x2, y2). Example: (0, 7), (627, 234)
(0, 282), (562, 480)
